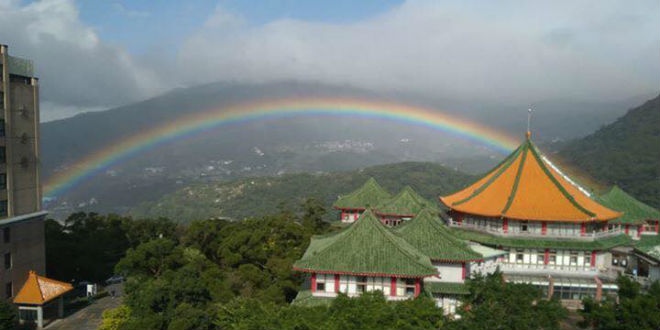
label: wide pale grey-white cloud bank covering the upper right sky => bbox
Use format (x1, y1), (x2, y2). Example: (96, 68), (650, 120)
(179, 1), (660, 102)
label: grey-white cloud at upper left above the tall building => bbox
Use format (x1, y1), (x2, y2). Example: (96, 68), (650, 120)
(0, 0), (166, 118)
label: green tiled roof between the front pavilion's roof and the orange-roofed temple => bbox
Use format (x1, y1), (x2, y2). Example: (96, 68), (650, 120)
(394, 209), (483, 262)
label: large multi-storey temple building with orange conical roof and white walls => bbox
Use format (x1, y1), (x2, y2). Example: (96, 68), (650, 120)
(440, 133), (631, 306)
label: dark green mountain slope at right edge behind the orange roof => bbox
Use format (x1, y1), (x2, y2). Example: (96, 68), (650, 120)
(559, 96), (660, 208)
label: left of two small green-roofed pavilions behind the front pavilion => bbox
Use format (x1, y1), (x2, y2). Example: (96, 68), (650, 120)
(333, 178), (392, 223)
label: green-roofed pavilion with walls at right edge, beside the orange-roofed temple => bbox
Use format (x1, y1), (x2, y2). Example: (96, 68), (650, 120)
(599, 186), (660, 239)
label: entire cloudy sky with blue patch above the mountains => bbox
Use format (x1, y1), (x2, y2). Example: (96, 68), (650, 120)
(0, 0), (660, 121)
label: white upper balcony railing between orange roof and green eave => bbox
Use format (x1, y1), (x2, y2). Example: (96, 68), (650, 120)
(448, 220), (623, 241)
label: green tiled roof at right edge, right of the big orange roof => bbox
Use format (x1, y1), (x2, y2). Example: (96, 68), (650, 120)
(599, 186), (660, 224)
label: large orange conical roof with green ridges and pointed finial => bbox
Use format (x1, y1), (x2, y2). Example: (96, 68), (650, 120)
(440, 134), (622, 222)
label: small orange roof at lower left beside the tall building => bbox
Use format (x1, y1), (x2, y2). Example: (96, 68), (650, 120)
(14, 271), (73, 305)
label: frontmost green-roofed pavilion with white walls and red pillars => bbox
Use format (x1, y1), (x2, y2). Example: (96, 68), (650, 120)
(293, 209), (437, 300)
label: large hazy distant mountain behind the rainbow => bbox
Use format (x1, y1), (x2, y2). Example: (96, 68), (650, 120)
(41, 81), (644, 217)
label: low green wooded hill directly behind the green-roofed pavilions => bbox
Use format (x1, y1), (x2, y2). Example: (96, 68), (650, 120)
(130, 162), (474, 222)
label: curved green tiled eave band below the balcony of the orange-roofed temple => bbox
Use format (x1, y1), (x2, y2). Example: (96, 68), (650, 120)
(451, 228), (632, 251)
